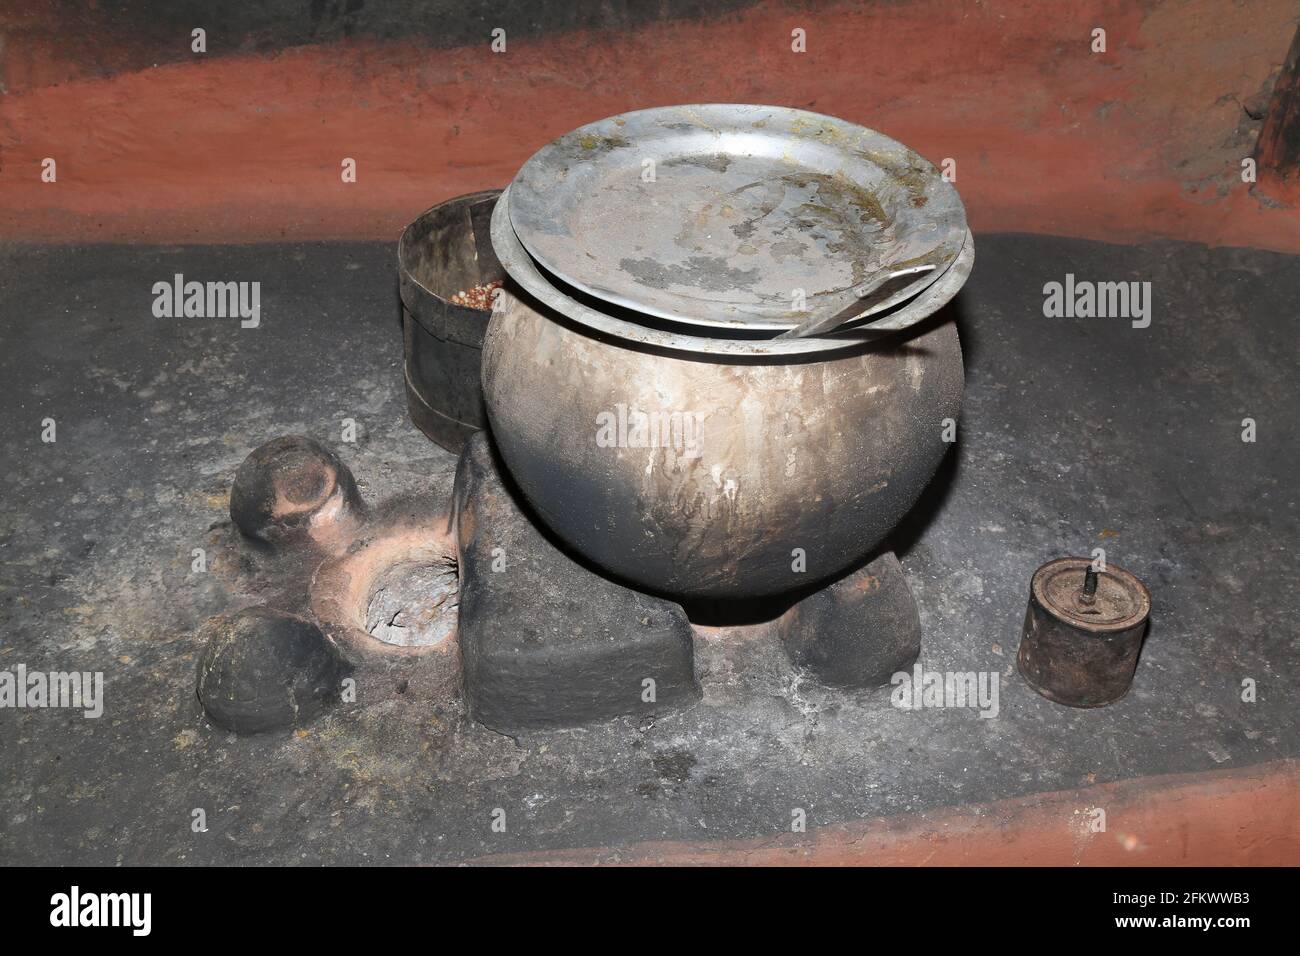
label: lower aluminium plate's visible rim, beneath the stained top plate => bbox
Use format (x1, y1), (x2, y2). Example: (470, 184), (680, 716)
(491, 187), (975, 362)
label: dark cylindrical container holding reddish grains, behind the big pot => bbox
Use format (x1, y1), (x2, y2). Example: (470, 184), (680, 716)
(398, 190), (506, 454)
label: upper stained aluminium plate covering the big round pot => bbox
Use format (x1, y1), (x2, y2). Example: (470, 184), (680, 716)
(510, 104), (966, 329)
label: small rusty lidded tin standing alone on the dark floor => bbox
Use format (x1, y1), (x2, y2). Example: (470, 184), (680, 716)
(1017, 558), (1151, 708)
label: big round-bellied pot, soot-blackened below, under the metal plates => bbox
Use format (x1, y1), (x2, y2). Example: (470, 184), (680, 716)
(482, 290), (963, 598)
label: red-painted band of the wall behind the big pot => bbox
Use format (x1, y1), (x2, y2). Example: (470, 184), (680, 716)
(0, 0), (1300, 251)
